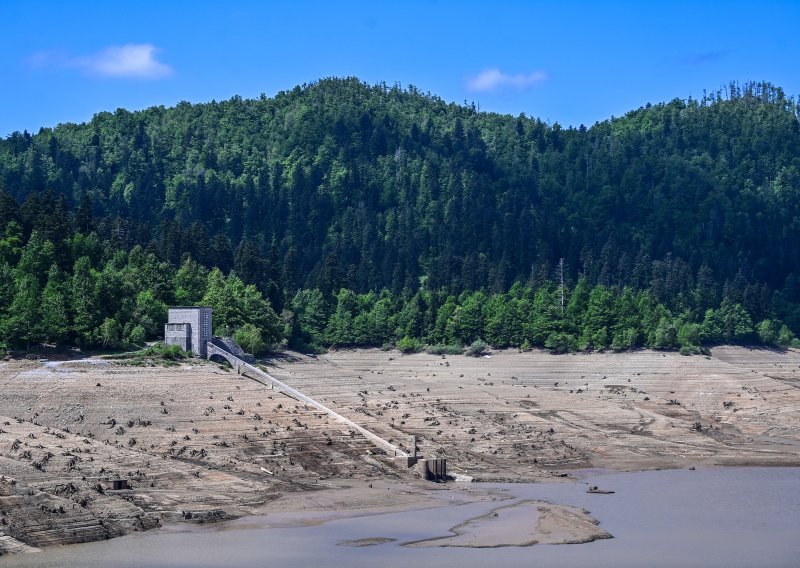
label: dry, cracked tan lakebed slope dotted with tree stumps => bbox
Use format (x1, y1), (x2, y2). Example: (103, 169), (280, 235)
(0, 347), (800, 554)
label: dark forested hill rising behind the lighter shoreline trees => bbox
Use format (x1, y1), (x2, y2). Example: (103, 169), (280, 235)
(0, 75), (800, 350)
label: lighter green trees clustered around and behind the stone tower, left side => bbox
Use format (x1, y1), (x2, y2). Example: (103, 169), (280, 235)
(0, 222), (283, 352)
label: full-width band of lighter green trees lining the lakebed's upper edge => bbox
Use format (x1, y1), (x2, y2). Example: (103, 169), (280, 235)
(0, 221), (798, 354)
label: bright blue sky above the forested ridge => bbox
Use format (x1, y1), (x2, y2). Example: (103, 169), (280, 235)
(0, 0), (800, 136)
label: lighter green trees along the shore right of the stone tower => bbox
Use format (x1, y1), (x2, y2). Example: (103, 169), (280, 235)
(296, 278), (799, 353)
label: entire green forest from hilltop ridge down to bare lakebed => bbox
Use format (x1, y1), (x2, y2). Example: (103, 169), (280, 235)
(0, 79), (800, 353)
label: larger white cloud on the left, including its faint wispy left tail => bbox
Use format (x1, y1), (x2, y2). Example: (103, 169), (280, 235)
(26, 43), (173, 79)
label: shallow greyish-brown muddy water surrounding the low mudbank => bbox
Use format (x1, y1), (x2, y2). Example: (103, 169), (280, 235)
(0, 468), (800, 568)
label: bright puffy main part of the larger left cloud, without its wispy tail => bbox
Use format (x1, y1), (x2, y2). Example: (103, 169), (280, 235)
(70, 43), (172, 79)
